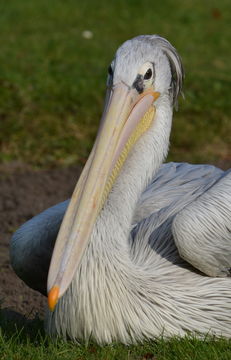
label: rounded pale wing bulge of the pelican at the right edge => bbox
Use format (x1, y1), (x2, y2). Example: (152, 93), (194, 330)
(172, 169), (231, 276)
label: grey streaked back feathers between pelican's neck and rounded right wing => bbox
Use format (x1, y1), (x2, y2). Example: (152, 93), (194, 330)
(130, 163), (226, 267)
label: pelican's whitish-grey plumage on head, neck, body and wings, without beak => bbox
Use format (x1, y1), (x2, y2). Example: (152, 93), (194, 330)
(11, 36), (231, 344)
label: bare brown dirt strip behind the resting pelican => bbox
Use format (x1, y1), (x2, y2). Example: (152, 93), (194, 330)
(0, 159), (231, 324)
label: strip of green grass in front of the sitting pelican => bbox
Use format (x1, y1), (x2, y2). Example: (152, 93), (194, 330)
(0, 320), (231, 360)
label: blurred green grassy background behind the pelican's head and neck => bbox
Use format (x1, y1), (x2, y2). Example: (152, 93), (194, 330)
(0, 0), (231, 168)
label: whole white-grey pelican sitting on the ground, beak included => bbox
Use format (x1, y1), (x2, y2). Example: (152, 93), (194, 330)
(10, 35), (231, 344)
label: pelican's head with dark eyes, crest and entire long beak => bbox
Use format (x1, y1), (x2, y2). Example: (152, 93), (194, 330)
(47, 35), (183, 310)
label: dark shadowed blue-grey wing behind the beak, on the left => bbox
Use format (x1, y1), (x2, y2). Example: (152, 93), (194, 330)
(10, 200), (69, 295)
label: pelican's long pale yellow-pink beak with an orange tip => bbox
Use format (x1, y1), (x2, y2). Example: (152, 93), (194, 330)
(47, 83), (160, 310)
